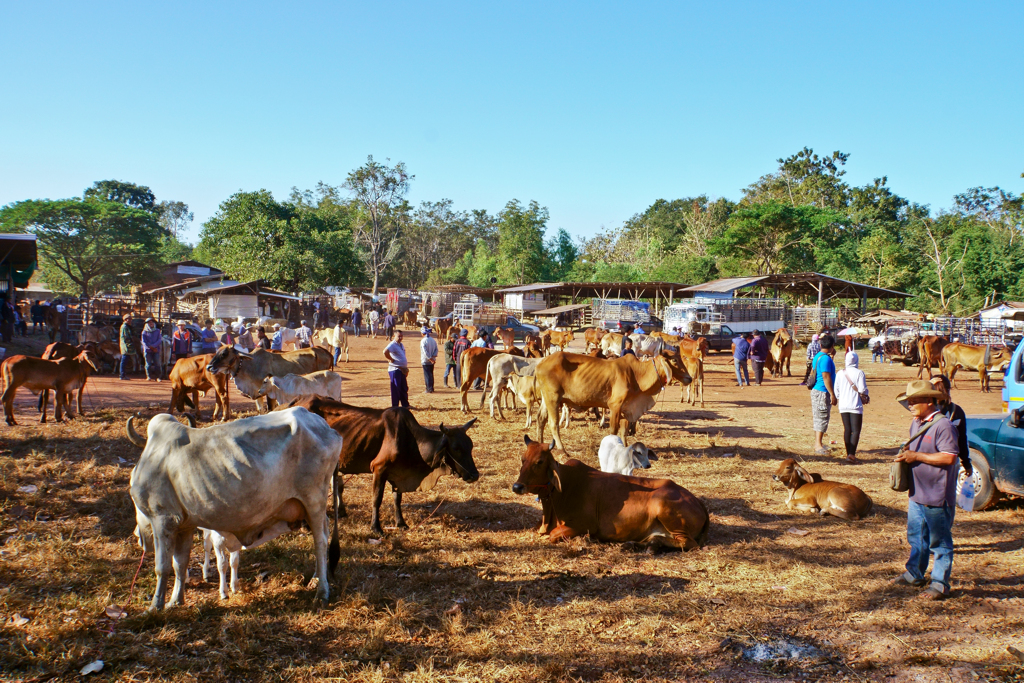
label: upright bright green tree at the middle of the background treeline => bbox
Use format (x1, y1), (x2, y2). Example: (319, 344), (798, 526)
(497, 200), (548, 285)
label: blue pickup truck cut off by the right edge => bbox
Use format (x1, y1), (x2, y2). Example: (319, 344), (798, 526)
(961, 342), (1024, 510)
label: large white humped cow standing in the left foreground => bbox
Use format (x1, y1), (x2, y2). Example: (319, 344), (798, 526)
(125, 408), (342, 611)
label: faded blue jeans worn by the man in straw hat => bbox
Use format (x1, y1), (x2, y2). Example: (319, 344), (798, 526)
(903, 501), (955, 595)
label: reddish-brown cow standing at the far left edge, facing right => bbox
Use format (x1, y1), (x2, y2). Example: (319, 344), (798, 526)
(0, 349), (99, 425)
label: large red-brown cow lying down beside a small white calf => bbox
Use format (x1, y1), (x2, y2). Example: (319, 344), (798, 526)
(512, 436), (710, 550)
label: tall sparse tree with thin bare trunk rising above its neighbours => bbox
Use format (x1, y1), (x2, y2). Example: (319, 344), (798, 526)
(344, 156), (416, 295)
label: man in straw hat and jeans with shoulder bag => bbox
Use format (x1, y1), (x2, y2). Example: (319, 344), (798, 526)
(892, 380), (958, 600)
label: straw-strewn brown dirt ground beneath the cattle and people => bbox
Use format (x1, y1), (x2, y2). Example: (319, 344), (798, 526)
(0, 333), (1024, 681)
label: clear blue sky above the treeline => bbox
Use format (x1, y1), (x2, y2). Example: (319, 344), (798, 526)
(0, 1), (1024, 240)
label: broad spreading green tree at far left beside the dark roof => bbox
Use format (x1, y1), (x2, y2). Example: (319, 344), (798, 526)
(0, 193), (163, 297)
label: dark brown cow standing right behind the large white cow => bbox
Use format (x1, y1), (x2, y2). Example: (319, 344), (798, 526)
(287, 396), (480, 536)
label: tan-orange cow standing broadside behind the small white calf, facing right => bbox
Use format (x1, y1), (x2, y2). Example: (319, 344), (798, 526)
(537, 351), (691, 449)
